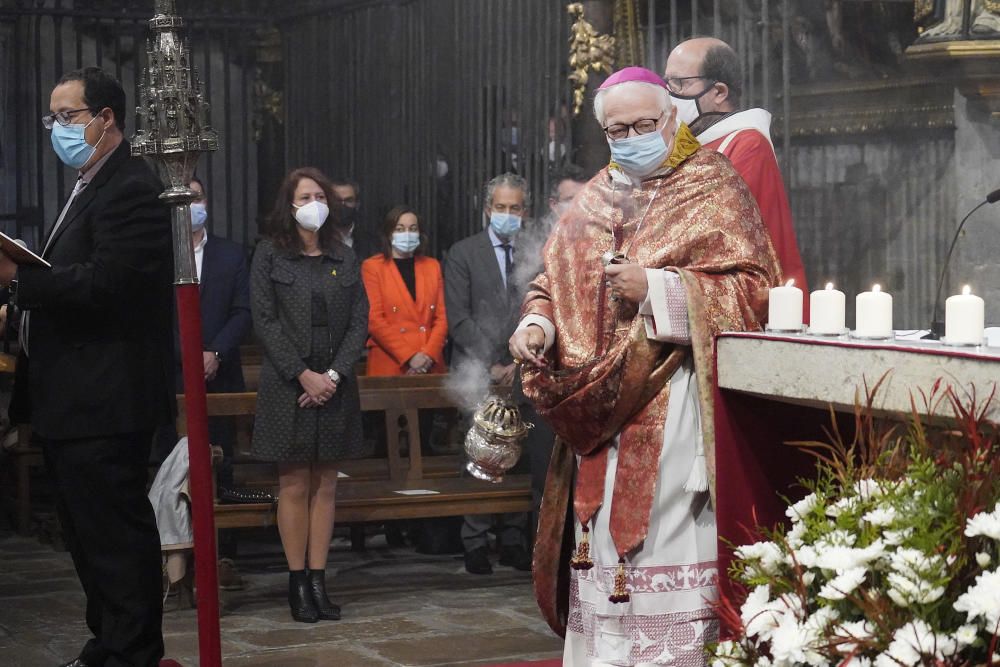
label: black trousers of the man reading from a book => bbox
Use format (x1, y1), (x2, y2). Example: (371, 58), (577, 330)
(35, 432), (163, 667)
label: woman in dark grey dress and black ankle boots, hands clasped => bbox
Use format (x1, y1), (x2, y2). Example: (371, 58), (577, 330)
(250, 168), (372, 623)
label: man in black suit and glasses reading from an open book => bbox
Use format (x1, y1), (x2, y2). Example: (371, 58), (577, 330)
(0, 67), (173, 667)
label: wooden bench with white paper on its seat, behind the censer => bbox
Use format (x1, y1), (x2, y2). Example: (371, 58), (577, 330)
(177, 375), (531, 529)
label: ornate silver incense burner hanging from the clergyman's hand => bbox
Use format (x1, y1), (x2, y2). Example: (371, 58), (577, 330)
(465, 394), (534, 484)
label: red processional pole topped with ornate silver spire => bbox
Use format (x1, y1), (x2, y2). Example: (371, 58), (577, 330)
(132, 0), (222, 667)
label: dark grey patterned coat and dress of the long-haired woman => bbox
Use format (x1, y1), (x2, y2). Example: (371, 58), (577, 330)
(250, 240), (372, 463)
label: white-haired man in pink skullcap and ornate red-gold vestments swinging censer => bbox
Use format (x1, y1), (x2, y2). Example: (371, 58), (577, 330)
(510, 67), (777, 667)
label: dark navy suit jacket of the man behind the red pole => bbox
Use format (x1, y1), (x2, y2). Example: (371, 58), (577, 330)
(174, 234), (252, 392)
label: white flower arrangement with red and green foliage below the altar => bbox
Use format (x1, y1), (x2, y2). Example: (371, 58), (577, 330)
(710, 390), (1000, 667)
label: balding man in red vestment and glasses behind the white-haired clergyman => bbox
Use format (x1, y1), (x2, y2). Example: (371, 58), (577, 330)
(666, 37), (809, 304)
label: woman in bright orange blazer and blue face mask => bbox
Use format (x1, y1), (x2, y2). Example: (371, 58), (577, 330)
(361, 206), (448, 375)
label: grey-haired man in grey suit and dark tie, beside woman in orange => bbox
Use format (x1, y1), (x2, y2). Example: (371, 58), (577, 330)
(444, 173), (531, 574)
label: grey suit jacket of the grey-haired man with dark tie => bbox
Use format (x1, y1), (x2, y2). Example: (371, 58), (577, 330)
(444, 230), (521, 368)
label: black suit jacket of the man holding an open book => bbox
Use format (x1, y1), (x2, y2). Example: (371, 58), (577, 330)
(11, 141), (174, 439)
